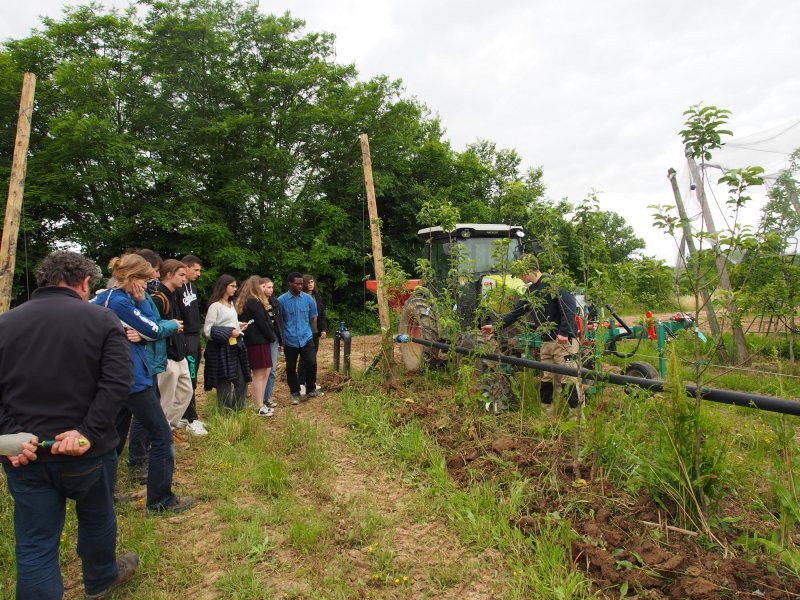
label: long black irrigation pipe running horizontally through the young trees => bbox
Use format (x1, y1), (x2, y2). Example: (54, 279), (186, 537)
(394, 334), (800, 417)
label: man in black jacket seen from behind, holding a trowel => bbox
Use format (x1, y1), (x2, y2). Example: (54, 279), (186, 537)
(0, 252), (138, 598)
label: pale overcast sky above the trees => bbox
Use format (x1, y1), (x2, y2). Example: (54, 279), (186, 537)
(0, 0), (800, 262)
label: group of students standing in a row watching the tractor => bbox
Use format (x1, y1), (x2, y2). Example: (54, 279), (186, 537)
(92, 249), (327, 512)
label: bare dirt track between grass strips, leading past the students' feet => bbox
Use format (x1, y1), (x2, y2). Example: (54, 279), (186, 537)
(256, 336), (502, 599)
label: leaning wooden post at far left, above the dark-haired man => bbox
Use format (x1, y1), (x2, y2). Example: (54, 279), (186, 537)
(0, 73), (36, 314)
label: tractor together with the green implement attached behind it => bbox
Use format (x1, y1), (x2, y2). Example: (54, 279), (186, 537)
(394, 223), (694, 410)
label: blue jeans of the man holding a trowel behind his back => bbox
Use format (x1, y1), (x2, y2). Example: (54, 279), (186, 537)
(3, 450), (119, 600)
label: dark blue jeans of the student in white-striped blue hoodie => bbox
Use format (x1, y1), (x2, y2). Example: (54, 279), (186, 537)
(125, 388), (178, 510)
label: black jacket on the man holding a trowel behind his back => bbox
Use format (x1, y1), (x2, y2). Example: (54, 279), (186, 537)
(0, 286), (133, 461)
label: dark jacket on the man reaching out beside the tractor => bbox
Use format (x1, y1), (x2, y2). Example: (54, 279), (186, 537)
(502, 274), (578, 340)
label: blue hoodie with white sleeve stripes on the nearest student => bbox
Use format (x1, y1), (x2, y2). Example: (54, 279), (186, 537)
(92, 288), (178, 394)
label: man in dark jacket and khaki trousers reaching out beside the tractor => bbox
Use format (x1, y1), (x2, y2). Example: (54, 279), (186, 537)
(481, 254), (578, 408)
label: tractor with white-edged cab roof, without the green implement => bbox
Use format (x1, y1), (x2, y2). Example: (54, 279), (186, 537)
(399, 223), (526, 371)
